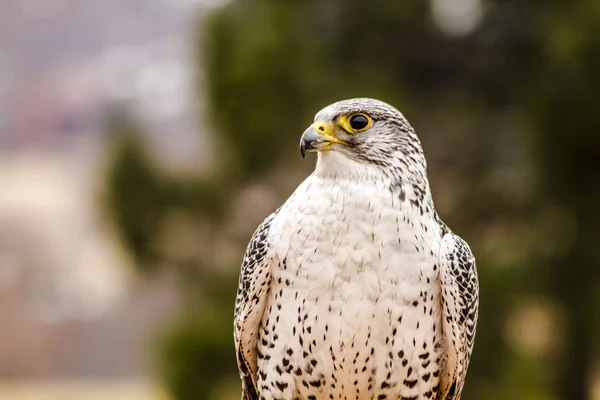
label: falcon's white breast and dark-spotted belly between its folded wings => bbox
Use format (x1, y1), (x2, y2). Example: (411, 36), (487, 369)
(259, 175), (441, 400)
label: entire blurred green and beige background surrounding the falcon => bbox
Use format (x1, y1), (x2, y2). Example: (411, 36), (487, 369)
(0, 0), (600, 400)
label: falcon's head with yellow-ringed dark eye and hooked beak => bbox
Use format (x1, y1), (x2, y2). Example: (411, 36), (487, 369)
(300, 98), (425, 176)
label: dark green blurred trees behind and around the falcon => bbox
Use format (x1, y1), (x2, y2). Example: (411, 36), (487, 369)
(106, 0), (600, 400)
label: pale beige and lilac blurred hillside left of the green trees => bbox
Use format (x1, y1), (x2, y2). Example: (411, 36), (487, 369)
(0, 0), (223, 400)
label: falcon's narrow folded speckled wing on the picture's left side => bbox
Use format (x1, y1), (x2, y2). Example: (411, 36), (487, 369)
(234, 212), (276, 400)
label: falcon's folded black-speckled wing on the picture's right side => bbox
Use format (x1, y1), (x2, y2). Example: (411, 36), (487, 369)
(439, 231), (479, 400)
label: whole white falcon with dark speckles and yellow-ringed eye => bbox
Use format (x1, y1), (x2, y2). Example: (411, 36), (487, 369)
(234, 98), (479, 400)
